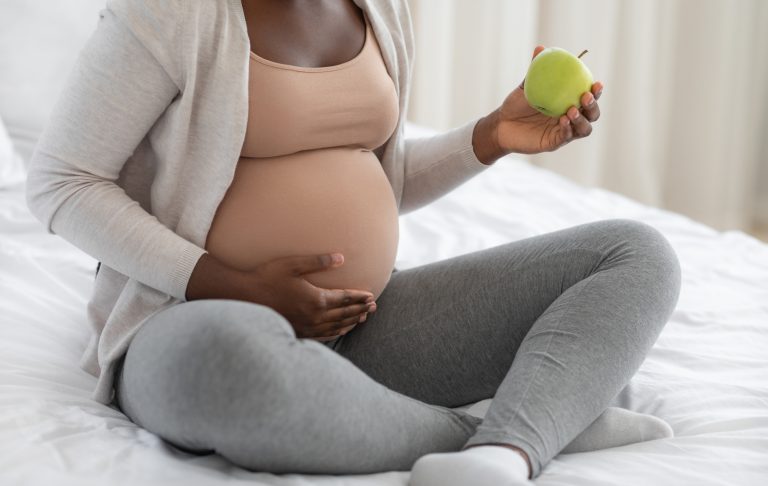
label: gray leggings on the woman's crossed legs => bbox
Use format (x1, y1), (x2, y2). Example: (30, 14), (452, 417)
(115, 219), (681, 477)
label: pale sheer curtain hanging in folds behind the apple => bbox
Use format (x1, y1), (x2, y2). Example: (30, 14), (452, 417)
(408, 0), (768, 234)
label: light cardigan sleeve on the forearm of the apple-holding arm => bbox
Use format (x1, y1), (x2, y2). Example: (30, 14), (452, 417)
(399, 118), (490, 214)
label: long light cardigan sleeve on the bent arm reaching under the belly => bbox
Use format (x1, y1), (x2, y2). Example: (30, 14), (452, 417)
(26, 0), (205, 300)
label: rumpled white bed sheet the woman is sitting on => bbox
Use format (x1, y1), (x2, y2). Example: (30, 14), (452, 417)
(0, 125), (768, 486)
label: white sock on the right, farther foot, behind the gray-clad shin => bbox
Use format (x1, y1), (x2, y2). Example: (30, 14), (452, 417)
(561, 407), (674, 454)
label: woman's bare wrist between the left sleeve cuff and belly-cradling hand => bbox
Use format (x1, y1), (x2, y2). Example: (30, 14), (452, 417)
(186, 253), (245, 301)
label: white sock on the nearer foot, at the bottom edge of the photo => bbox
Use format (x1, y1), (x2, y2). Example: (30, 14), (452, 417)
(408, 445), (533, 486)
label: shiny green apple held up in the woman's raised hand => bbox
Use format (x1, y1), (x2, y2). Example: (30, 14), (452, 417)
(524, 47), (594, 117)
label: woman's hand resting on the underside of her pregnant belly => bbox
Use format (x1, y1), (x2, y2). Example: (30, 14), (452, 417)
(246, 254), (376, 341)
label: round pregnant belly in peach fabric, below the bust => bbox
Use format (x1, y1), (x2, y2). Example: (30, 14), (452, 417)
(205, 147), (399, 298)
